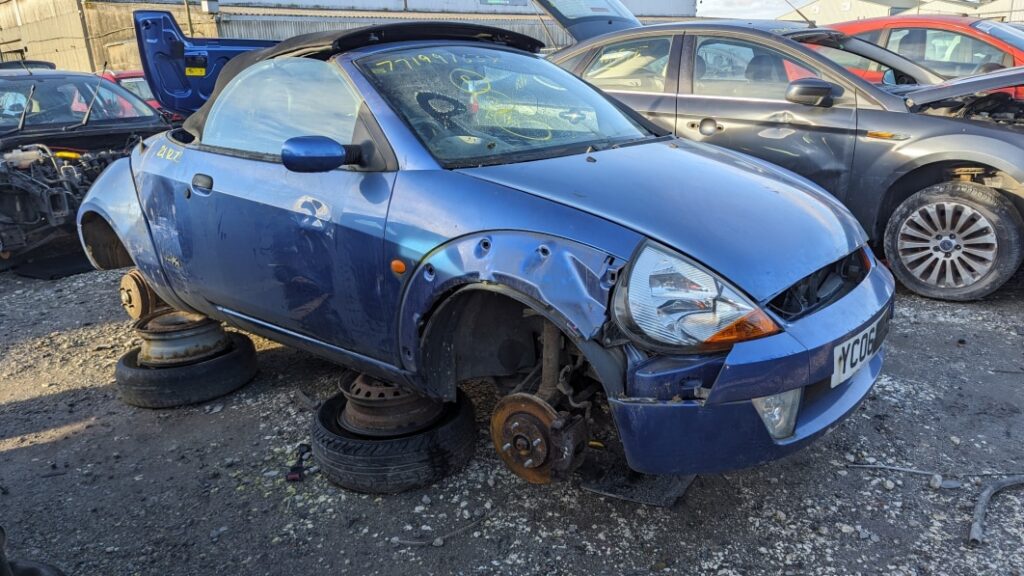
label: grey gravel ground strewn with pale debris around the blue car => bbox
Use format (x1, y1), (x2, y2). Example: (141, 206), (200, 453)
(0, 266), (1024, 576)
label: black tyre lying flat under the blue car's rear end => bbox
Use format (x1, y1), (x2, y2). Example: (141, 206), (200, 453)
(114, 332), (258, 408)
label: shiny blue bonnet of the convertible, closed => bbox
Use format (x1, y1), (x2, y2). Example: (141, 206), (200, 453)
(459, 140), (866, 301)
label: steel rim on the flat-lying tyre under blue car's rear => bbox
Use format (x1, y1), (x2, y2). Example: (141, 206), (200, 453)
(134, 310), (230, 368)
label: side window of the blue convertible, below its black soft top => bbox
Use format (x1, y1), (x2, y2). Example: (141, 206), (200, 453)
(203, 58), (362, 155)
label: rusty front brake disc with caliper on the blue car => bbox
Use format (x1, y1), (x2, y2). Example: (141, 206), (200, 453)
(490, 393), (589, 484)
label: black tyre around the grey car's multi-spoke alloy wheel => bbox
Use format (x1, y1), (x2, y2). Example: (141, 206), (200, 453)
(885, 181), (1024, 301)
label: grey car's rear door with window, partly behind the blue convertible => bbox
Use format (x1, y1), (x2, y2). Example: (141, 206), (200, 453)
(581, 33), (682, 130)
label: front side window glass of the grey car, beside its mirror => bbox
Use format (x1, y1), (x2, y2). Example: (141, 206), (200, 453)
(693, 37), (818, 100)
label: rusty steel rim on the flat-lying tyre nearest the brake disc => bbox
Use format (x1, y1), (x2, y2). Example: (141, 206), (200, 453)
(338, 374), (444, 438)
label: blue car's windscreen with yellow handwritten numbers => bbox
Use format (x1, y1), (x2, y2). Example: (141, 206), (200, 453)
(357, 46), (654, 168)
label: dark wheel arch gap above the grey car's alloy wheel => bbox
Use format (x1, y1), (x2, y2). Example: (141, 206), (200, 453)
(868, 161), (1024, 239)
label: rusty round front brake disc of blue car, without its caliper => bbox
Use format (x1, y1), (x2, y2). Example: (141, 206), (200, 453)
(490, 394), (558, 484)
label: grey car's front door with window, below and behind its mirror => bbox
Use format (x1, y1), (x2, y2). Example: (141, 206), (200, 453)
(676, 33), (857, 198)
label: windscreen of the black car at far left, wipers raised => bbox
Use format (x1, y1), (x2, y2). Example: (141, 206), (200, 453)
(0, 75), (156, 129)
